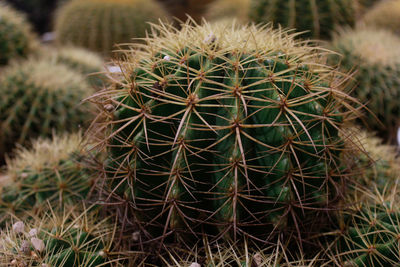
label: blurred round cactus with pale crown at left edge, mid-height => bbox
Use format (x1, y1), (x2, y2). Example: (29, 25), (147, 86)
(0, 60), (93, 158)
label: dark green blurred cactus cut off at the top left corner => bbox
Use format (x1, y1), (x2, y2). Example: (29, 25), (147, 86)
(0, 3), (37, 65)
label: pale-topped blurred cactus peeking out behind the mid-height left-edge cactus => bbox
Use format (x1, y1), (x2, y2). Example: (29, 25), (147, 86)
(41, 47), (105, 88)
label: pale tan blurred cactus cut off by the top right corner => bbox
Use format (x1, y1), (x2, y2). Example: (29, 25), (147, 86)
(362, 0), (400, 36)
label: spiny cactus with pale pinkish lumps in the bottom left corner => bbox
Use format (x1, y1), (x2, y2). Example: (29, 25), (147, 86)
(0, 206), (114, 267)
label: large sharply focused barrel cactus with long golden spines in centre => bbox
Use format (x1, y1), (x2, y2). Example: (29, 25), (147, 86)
(94, 21), (360, 243)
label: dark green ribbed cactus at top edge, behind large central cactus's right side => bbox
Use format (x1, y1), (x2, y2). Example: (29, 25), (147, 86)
(250, 0), (356, 39)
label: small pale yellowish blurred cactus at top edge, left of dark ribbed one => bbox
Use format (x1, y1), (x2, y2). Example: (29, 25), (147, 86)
(204, 0), (250, 23)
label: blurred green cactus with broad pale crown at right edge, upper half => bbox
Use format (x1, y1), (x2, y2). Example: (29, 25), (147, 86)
(332, 28), (400, 142)
